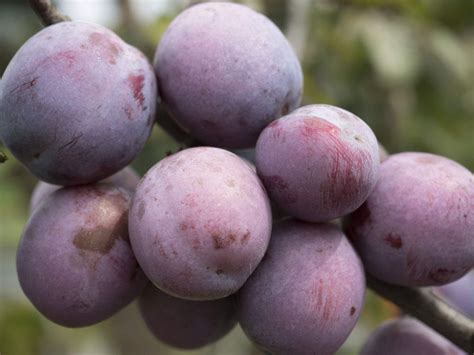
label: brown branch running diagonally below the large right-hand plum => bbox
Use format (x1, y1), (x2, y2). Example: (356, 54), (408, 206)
(366, 275), (474, 354)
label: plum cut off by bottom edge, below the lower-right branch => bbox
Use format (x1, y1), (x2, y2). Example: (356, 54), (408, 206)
(360, 317), (465, 355)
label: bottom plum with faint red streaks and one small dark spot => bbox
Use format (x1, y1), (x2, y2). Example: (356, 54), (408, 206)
(238, 220), (365, 355)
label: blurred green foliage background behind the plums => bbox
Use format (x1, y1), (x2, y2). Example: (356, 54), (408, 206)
(0, 0), (474, 355)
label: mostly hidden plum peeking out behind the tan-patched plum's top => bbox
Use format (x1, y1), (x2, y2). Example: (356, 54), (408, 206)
(30, 166), (140, 212)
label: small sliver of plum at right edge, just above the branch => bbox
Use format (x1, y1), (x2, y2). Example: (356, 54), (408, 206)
(434, 270), (474, 319)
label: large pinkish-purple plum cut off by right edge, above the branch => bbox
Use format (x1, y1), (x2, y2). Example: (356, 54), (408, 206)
(345, 152), (474, 287)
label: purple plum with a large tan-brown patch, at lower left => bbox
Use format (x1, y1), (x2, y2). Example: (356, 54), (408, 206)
(17, 184), (147, 327)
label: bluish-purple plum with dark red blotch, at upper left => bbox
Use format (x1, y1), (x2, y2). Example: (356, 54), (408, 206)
(0, 21), (157, 185)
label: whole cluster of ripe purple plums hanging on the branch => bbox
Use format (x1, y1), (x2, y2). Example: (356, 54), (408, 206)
(0, 3), (474, 354)
